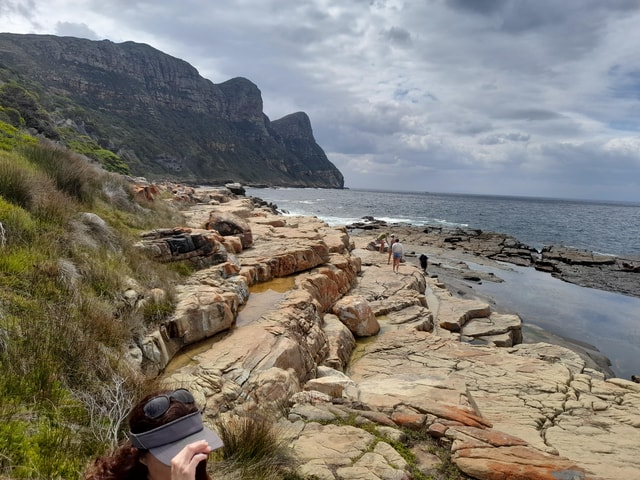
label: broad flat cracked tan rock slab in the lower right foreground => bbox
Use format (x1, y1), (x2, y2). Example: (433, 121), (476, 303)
(348, 331), (640, 480)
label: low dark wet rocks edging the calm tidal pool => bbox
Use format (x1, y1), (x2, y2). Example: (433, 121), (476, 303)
(346, 221), (640, 378)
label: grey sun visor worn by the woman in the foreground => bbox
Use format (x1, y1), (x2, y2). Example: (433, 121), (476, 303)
(129, 411), (223, 465)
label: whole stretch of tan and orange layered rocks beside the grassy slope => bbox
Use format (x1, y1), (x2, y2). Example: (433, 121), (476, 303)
(131, 186), (640, 480)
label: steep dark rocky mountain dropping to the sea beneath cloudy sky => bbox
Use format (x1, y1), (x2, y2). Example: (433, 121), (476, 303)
(0, 33), (344, 188)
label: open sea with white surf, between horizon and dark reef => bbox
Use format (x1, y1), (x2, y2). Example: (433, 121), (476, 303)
(246, 187), (640, 258)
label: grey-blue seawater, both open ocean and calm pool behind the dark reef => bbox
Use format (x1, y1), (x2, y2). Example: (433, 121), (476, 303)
(246, 188), (640, 379)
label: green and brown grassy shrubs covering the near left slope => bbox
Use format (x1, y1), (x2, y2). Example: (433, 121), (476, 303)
(0, 128), (182, 479)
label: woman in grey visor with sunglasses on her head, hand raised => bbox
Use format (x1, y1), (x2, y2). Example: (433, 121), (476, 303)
(84, 389), (222, 480)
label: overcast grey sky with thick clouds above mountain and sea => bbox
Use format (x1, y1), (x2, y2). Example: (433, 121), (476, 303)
(0, 0), (640, 202)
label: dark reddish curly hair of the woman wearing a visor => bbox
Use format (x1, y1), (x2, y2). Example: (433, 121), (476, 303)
(83, 390), (210, 480)
